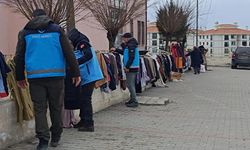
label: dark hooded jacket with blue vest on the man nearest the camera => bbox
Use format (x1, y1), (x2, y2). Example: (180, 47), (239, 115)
(14, 15), (80, 81)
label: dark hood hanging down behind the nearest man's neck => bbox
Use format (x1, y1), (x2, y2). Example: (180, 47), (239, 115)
(24, 15), (54, 30)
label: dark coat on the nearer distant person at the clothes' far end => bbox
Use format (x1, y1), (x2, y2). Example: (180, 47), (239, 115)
(186, 48), (203, 67)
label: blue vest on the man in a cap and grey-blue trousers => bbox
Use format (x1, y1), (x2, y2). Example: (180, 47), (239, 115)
(123, 48), (140, 69)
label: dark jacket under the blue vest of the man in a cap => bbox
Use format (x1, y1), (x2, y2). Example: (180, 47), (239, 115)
(116, 38), (139, 72)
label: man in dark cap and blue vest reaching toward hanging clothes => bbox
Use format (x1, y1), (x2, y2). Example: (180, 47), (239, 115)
(110, 33), (140, 107)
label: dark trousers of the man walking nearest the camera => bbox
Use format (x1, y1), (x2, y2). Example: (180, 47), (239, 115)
(29, 78), (64, 141)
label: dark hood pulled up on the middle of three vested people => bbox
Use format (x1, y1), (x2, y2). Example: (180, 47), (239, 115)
(68, 29), (91, 48)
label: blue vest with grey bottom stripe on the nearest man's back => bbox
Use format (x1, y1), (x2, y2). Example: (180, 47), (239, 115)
(25, 25), (65, 79)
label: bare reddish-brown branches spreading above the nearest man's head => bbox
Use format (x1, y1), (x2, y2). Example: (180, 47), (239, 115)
(0, 0), (87, 29)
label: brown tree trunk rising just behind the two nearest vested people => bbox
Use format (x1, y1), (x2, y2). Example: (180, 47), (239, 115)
(66, 0), (76, 32)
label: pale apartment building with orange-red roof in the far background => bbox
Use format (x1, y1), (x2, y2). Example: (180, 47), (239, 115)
(187, 24), (250, 56)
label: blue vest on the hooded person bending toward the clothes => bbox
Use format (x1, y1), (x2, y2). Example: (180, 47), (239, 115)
(75, 48), (104, 85)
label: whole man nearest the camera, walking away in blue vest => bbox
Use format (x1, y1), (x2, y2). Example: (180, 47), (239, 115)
(14, 9), (81, 150)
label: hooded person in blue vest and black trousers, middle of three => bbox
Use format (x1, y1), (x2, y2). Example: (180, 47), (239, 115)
(66, 29), (104, 132)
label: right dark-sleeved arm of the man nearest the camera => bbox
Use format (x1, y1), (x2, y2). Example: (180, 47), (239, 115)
(60, 29), (80, 77)
